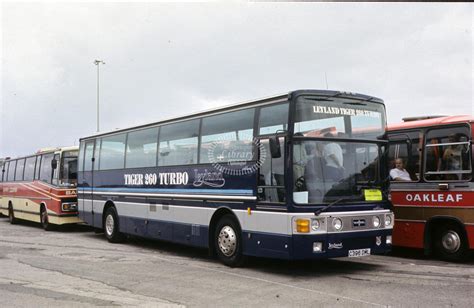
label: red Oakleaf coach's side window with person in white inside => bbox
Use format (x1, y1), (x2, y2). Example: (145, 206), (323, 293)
(388, 131), (422, 181)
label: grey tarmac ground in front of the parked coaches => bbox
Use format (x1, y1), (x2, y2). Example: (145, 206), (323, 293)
(0, 218), (474, 307)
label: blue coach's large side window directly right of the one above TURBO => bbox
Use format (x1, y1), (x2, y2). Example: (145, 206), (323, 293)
(199, 108), (255, 163)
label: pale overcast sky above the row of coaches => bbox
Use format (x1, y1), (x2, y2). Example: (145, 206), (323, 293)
(0, 1), (474, 157)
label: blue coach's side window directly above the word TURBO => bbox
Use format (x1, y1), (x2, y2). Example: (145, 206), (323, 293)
(158, 120), (200, 166)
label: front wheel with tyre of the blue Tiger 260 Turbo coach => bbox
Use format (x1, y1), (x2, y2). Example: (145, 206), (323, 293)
(214, 214), (245, 267)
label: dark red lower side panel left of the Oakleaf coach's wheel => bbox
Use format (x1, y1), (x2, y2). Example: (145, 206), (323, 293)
(393, 220), (425, 248)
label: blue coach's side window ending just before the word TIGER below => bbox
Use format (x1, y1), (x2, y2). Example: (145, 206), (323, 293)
(99, 134), (126, 170)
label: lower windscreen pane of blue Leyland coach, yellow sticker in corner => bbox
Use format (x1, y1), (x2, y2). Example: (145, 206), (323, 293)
(293, 140), (381, 204)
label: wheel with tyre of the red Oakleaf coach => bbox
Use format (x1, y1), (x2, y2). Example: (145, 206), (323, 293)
(434, 223), (468, 262)
